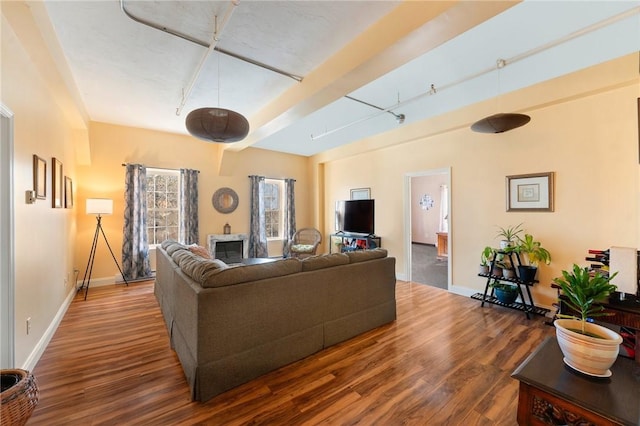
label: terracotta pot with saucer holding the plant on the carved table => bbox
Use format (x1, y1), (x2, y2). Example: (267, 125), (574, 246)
(554, 319), (622, 377)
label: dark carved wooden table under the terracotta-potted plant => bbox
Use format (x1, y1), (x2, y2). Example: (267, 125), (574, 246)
(512, 337), (640, 426)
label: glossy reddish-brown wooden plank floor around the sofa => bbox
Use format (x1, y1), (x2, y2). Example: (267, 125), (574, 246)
(28, 281), (554, 426)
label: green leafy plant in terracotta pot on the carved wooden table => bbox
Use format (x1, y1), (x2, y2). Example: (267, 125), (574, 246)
(553, 264), (622, 377)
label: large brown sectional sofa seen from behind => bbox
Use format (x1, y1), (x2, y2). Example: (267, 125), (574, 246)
(155, 241), (396, 401)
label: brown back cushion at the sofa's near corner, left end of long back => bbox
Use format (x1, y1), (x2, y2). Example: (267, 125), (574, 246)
(202, 259), (302, 287)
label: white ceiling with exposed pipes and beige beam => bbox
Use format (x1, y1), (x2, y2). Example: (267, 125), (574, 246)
(45, 0), (640, 156)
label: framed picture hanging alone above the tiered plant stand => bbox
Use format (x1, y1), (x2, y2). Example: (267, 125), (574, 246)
(506, 172), (554, 212)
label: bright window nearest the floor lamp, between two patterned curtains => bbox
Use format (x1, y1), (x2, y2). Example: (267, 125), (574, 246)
(147, 169), (180, 247)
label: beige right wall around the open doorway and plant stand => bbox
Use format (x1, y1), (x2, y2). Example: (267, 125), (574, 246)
(314, 55), (640, 306)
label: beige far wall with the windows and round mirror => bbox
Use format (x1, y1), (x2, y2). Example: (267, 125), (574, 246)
(75, 122), (311, 282)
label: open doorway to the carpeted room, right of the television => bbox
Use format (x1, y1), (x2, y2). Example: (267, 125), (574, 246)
(405, 169), (451, 290)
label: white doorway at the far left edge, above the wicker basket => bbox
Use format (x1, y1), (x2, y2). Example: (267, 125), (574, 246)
(0, 105), (15, 369)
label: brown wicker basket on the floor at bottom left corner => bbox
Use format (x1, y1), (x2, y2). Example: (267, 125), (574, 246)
(0, 369), (38, 425)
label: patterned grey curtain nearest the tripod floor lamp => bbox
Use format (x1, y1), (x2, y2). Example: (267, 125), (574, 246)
(122, 164), (151, 280)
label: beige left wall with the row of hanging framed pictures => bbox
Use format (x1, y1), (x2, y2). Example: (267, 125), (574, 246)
(1, 10), (77, 367)
